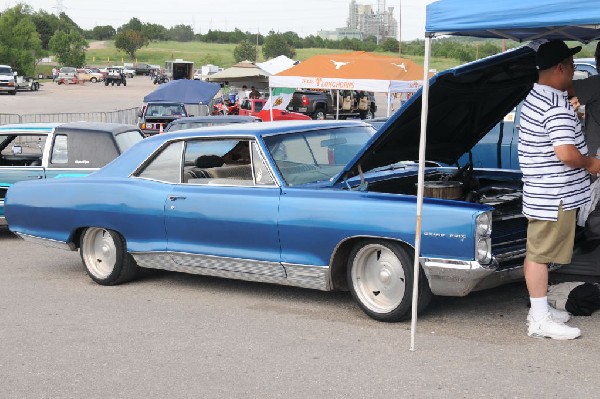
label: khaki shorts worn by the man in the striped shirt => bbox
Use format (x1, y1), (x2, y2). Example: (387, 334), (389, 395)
(525, 204), (577, 265)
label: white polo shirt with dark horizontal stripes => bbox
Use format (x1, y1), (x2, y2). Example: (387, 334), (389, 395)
(518, 83), (590, 221)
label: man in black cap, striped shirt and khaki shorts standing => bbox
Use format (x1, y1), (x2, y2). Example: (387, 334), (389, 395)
(519, 40), (600, 339)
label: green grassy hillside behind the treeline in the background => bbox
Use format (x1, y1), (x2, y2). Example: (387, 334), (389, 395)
(86, 40), (460, 71)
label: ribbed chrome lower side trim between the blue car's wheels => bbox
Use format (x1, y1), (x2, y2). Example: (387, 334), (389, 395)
(131, 252), (331, 291)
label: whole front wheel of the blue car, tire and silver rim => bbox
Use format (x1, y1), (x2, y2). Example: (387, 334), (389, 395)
(348, 240), (432, 322)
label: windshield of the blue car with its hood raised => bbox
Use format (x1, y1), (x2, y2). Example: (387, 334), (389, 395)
(264, 126), (374, 186)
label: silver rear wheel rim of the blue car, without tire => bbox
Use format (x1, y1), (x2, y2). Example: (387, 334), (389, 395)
(81, 227), (118, 280)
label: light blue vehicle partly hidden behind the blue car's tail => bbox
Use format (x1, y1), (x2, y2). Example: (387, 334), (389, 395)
(0, 122), (144, 226)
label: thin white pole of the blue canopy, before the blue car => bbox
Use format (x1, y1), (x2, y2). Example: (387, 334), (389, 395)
(410, 36), (431, 351)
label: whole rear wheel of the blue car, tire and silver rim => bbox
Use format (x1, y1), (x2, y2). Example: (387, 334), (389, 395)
(80, 227), (139, 285)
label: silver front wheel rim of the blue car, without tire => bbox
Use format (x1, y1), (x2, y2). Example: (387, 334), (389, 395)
(350, 243), (406, 314)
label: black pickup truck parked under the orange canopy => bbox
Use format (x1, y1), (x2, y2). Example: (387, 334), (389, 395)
(287, 90), (377, 120)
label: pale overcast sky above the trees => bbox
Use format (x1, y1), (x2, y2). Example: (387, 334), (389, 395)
(0, 0), (432, 41)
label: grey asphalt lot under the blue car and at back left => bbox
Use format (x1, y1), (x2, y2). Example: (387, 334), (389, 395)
(0, 77), (600, 399)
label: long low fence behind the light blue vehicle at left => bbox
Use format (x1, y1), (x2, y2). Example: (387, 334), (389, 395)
(0, 108), (139, 125)
